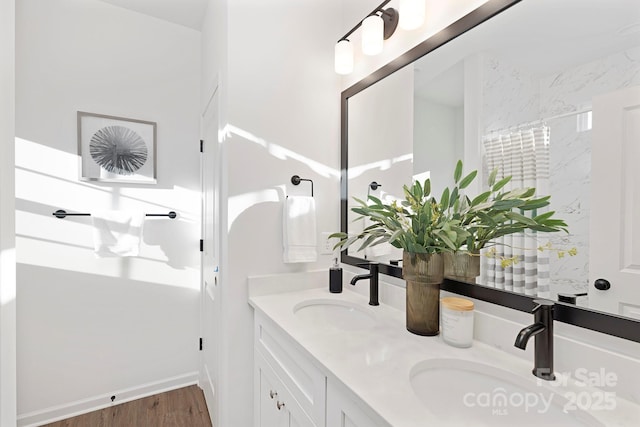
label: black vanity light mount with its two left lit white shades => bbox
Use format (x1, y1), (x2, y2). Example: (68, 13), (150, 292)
(335, 0), (400, 74)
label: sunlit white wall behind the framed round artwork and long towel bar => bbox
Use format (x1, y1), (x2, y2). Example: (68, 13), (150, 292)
(16, 0), (200, 424)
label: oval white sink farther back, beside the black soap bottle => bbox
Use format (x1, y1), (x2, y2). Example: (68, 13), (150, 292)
(293, 299), (376, 331)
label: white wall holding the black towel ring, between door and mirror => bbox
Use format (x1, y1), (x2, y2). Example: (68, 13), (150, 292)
(203, 0), (341, 426)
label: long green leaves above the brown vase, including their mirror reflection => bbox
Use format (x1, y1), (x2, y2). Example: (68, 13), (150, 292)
(329, 161), (567, 253)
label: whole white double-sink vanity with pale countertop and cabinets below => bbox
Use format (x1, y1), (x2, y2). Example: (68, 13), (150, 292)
(250, 276), (640, 427)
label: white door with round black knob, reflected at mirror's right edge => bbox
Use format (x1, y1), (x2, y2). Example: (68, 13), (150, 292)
(589, 86), (640, 319)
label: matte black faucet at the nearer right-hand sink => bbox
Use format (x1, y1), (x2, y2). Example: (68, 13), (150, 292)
(514, 299), (556, 381)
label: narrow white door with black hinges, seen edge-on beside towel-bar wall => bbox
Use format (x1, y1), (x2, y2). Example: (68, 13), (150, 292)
(200, 83), (222, 427)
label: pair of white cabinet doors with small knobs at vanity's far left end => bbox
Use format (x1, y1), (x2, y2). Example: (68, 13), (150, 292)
(254, 352), (316, 427)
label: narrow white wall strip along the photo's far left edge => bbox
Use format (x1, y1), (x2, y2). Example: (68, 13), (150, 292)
(0, 0), (16, 427)
